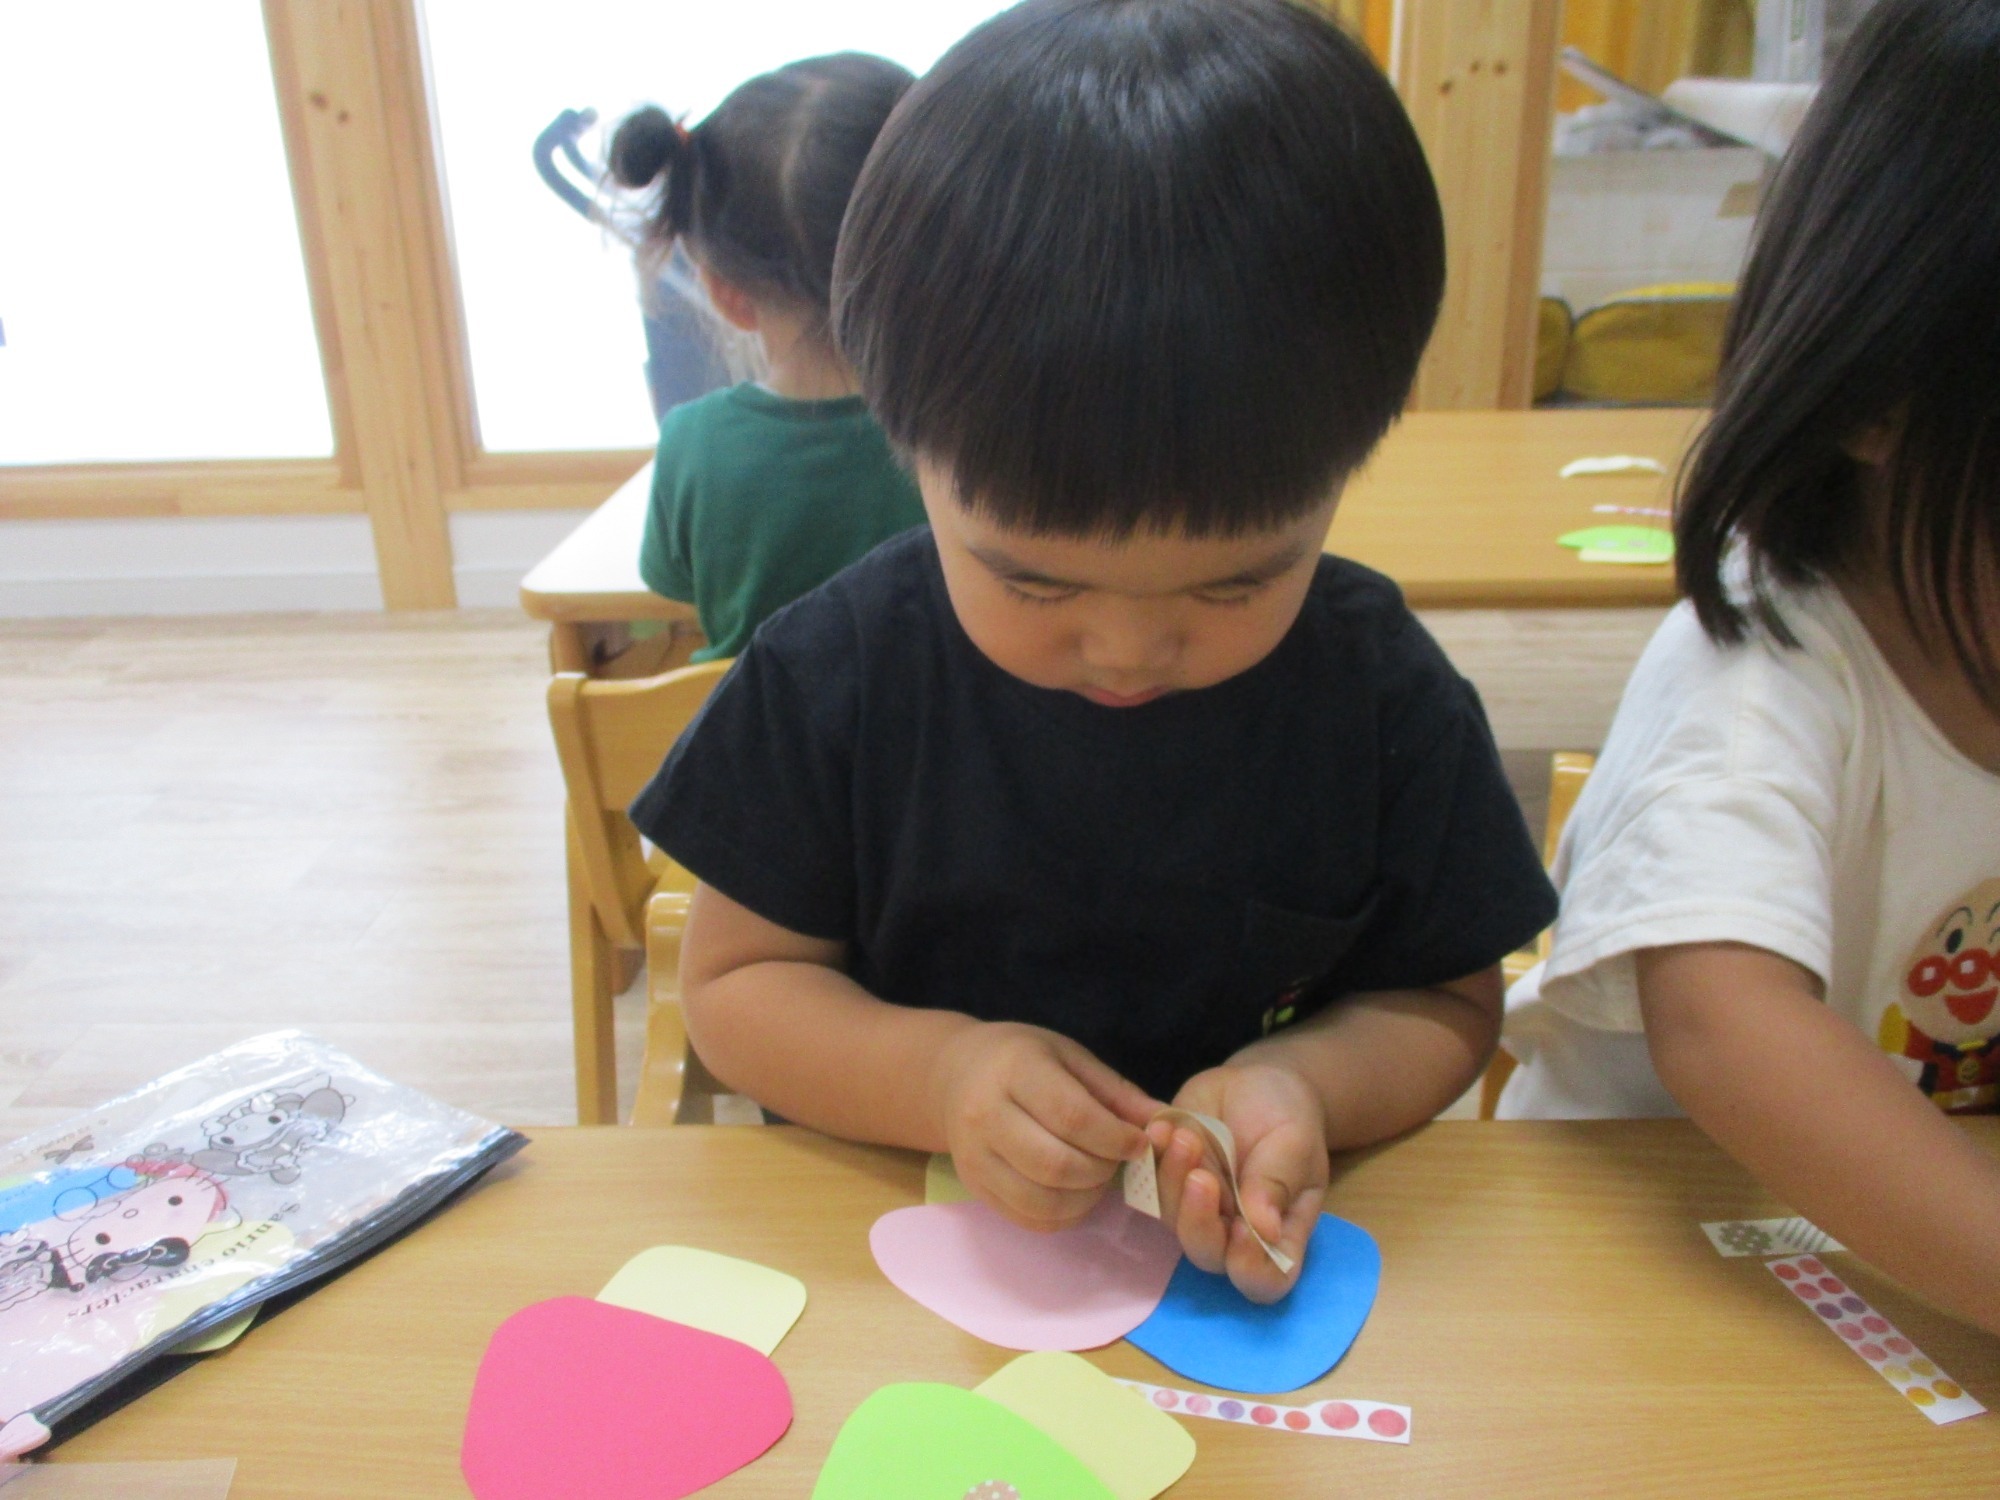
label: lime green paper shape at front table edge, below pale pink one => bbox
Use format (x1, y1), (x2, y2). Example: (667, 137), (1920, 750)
(812, 1382), (1116, 1500)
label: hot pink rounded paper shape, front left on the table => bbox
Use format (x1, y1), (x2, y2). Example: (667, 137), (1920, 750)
(458, 1296), (792, 1500)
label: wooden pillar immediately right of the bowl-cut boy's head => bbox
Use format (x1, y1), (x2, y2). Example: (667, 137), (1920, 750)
(1390, 0), (1562, 410)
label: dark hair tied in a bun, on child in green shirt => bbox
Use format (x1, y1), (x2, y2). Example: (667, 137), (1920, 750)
(608, 52), (912, 334)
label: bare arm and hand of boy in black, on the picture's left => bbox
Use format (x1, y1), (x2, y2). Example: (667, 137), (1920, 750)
(680, 884), (1160, 1228)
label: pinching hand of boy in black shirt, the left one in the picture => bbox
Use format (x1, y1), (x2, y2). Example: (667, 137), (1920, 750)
(938, 1022), (1160, 1230)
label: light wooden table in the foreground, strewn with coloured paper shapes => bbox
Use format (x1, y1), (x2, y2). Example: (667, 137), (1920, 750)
(56, 1120), (2000, 1500)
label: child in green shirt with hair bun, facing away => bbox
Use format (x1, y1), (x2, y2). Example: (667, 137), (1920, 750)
(610, 52), (924, 660)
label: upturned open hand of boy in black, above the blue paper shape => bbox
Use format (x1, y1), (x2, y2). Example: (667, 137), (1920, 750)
(1150, 1062), (1328, 1302)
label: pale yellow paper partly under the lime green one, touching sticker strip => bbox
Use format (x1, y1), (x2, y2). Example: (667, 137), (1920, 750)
(974, 1352), (1194, 1500)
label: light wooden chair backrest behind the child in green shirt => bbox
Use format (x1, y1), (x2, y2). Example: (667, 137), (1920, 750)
(548, 662), (730, 948)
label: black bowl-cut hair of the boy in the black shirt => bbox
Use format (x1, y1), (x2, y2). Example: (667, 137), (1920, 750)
(834, 0), (1444, 538)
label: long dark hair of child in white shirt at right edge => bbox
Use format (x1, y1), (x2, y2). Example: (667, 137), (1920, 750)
(1674, 0), (2000, 710)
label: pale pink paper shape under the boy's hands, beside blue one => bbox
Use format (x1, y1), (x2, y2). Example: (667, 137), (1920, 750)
(868, 1194), (1180, 1350)
